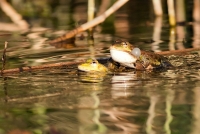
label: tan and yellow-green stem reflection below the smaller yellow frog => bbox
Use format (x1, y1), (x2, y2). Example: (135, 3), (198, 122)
(77, 84), (107, 134)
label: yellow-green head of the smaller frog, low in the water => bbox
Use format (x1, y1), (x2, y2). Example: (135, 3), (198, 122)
(78, 59), (108, 72)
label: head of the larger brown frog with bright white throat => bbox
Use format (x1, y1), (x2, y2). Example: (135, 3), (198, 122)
(110, 41), (140, 68)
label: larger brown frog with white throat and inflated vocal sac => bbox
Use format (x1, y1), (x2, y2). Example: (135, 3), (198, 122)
(110, 41), (173, 70)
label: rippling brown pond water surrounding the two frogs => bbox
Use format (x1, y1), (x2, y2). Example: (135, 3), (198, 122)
(0, 0), (200, 134)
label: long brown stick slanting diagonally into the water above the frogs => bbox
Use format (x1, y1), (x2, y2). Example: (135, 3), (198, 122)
(49, 0), (128, 44)
